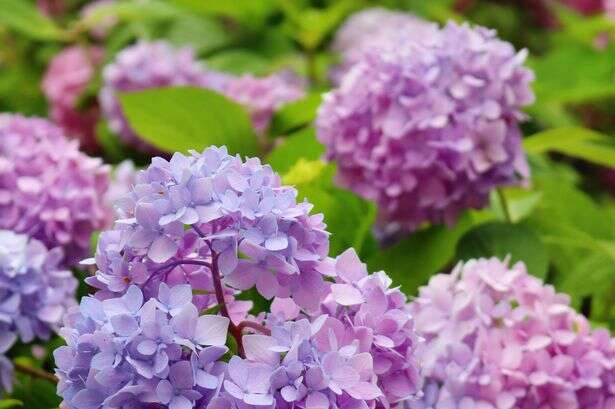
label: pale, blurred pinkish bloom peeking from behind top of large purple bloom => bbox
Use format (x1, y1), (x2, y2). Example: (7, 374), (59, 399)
(332, 7), (438, 84)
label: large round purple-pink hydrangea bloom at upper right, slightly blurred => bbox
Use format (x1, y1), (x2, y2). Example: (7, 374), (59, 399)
(317, 23), (533, 236)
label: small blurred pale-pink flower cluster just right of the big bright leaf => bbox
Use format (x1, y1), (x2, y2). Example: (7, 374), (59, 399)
(224, 73), (305, 134)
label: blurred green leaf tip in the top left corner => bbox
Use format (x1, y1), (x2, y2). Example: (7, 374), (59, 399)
(0, 0), (66, 40)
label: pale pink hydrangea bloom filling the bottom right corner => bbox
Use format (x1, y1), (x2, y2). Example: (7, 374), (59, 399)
(410, 258), (615, 409)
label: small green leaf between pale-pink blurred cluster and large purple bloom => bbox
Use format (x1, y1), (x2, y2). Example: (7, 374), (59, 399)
(269, 92), (322, 136)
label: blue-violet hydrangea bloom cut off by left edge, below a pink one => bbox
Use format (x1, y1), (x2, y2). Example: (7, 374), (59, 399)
(0, 230), (77, 392)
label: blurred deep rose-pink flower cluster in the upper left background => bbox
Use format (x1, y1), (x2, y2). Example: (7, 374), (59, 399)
(42, 46), (103, 152)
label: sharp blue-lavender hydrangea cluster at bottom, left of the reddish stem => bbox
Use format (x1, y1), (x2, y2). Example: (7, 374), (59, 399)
(54, 283), (229, 409)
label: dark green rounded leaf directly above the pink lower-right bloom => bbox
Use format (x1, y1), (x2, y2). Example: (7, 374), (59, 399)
(456, 222), (549, 279)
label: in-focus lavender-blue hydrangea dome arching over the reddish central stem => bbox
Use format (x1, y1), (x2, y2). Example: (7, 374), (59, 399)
(88, 147), (328, 310)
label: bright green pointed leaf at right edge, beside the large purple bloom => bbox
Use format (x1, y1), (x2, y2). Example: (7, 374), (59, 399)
(523, 127), (615, 167)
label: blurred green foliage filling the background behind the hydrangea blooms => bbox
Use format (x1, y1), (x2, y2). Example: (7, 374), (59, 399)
(0, 0), (615, 408)
